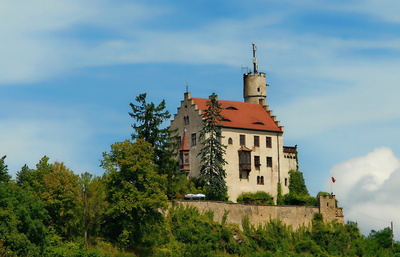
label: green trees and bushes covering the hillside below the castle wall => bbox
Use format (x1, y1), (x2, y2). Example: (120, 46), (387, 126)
(0, 151), (400, 257)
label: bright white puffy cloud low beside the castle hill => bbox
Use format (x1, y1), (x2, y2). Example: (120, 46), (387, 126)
(326, 147), (400, 237)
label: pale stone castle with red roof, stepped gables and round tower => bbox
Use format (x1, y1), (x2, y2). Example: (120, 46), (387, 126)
(170, 44), (297, 202)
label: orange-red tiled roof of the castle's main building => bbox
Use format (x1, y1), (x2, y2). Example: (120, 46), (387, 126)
(192, 98), (283, 133)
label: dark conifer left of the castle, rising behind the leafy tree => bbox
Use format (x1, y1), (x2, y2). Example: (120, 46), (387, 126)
(129, 93), (180, 198)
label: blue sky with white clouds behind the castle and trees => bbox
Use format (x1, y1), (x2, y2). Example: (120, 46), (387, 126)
(0, 0), (400, 236)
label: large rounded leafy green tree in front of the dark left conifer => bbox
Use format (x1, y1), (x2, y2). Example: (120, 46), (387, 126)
(101, 139), (168, 248)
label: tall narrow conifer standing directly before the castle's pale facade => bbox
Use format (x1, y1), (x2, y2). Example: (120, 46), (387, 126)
(199, 93), (227, 201)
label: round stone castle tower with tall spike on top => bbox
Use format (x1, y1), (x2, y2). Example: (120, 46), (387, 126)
(243, 44), (267, 107)
